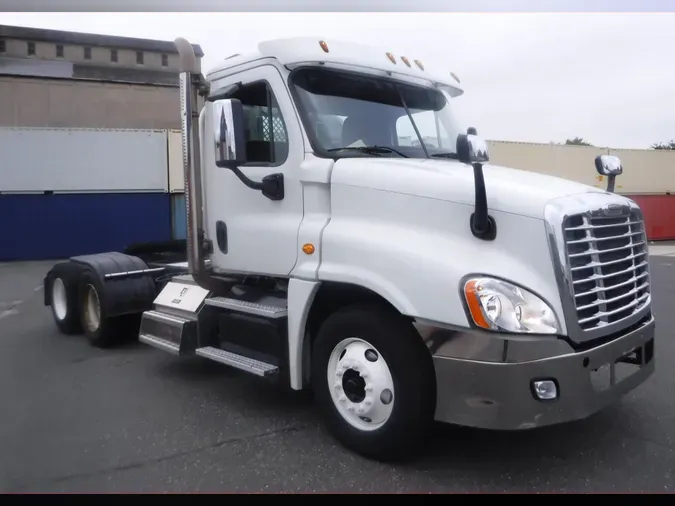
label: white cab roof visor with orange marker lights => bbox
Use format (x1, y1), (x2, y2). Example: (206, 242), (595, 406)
(208, 37), (463, 96)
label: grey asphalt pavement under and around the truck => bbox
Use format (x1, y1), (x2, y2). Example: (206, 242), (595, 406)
(0, 255), (675, 493)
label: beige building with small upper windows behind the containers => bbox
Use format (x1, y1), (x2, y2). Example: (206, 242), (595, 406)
(0, 25), (204, 129)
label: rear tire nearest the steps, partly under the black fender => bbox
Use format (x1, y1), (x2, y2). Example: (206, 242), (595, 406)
(79, 270), (128, 348)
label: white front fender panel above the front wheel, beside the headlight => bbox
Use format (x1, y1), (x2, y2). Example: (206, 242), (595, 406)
(318, 185), (567, 333)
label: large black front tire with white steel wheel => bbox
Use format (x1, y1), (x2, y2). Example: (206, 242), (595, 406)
(312, 305), (436, 461)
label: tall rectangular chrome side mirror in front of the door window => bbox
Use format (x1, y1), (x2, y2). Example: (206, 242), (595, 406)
(211, 99), (246, 169)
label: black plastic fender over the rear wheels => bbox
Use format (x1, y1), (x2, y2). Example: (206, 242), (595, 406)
(70, 252), (165, 317)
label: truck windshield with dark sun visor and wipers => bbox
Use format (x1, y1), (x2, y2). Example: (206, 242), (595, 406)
(292, 68), (461, 158)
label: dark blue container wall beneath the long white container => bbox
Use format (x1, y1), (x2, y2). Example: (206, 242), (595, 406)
(0, 193), (172, 261)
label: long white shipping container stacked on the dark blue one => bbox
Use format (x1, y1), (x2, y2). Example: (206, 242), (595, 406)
(0, 128), (169, 193)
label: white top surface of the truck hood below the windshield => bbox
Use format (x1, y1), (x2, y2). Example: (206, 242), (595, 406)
(331, 157), (605, 219)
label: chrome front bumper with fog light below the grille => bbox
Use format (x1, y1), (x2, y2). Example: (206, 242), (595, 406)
(433, 318), (655, 430)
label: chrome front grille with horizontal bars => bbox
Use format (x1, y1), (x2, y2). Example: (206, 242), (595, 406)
(563, 209), (650, 331)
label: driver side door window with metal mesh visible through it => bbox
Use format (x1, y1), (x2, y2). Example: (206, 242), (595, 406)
(231, 81), (288, 167)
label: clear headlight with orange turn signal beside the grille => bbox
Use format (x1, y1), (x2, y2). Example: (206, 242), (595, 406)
(464, 278), (560, 334)
